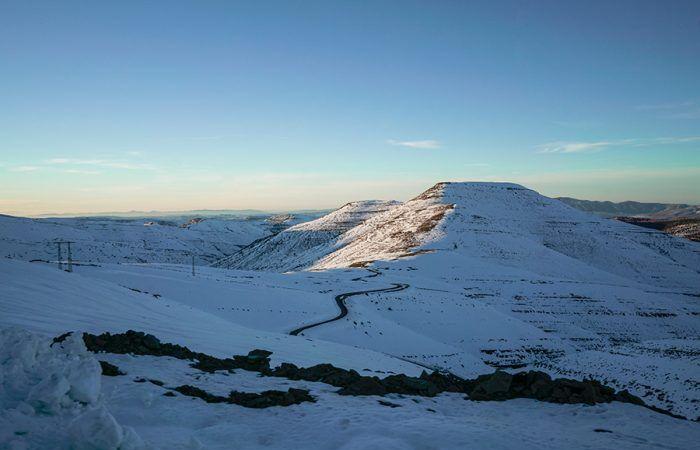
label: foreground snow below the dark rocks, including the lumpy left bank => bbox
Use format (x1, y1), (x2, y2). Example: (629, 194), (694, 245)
(0, 329), (700, 450)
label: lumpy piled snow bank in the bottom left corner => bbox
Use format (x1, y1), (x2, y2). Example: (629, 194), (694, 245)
(0, 328), (144, 450)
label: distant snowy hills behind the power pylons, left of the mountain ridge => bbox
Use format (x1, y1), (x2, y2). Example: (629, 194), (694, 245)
(0, 215), (294, 264)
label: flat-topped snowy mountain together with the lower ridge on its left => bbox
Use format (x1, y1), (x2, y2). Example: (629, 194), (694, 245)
(213, 183), (700, 287)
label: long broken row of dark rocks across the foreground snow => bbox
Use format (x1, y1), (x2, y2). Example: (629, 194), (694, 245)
(76, 330), (663, 412)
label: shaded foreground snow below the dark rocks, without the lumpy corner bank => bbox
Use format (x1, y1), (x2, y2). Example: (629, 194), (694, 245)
(95, 355), (700, 449)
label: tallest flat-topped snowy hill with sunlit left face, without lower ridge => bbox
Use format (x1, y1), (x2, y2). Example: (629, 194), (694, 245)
(340, 183), (700, 287)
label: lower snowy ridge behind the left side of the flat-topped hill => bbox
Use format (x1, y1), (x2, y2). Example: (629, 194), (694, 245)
(216, 200), (398, 272)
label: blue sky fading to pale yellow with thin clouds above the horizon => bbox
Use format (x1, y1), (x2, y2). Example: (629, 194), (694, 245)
(0, 0), (700, 215)
